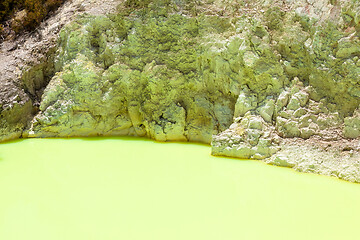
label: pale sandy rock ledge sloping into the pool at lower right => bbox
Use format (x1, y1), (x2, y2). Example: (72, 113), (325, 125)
(264, 139), (360, 183)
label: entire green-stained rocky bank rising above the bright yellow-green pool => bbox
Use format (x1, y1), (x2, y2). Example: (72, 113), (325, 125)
(0, 0), (360, 182)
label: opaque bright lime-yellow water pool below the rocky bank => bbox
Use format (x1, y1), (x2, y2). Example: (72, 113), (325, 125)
(0, 138), (360, 240)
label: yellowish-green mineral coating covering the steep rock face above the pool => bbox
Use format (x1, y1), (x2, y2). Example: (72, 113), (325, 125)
(28, 0), (360, 143)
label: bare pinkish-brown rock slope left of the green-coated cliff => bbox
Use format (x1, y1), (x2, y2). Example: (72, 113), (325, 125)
(0, 0), (119, 141)
